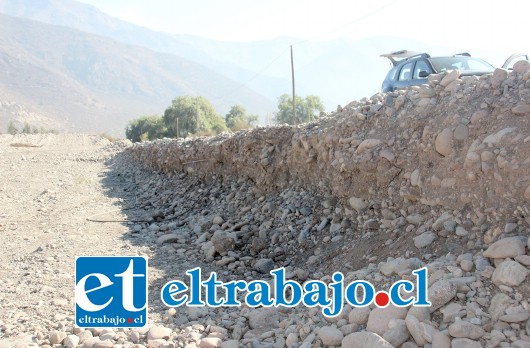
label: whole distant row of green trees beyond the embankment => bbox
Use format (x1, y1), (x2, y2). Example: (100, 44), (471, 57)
(125, 94), (324, 142)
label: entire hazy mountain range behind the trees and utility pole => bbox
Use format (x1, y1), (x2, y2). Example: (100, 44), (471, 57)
(0, 0), (445, 134)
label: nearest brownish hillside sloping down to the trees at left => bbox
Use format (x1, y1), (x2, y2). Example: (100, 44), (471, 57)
(0, 15), (274, 134)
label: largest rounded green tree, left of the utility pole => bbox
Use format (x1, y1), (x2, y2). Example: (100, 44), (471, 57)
(164, 96), (227, 137)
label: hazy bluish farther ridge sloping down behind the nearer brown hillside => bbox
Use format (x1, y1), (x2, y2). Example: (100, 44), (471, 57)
(0, 0), (290, 112)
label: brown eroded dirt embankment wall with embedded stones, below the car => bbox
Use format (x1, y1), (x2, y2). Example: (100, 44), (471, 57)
(128, 62), (530, 221)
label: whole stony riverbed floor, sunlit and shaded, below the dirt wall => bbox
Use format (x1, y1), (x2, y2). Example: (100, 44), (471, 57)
(0, 134), (530, 348)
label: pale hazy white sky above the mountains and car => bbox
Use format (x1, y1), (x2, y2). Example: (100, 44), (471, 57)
(76, 0), (530, 65)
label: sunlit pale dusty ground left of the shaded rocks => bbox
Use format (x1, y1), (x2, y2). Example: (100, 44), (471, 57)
(0, 135), (149, 339)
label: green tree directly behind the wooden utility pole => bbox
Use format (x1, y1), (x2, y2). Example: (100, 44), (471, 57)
(274, 94), (324, 125)
